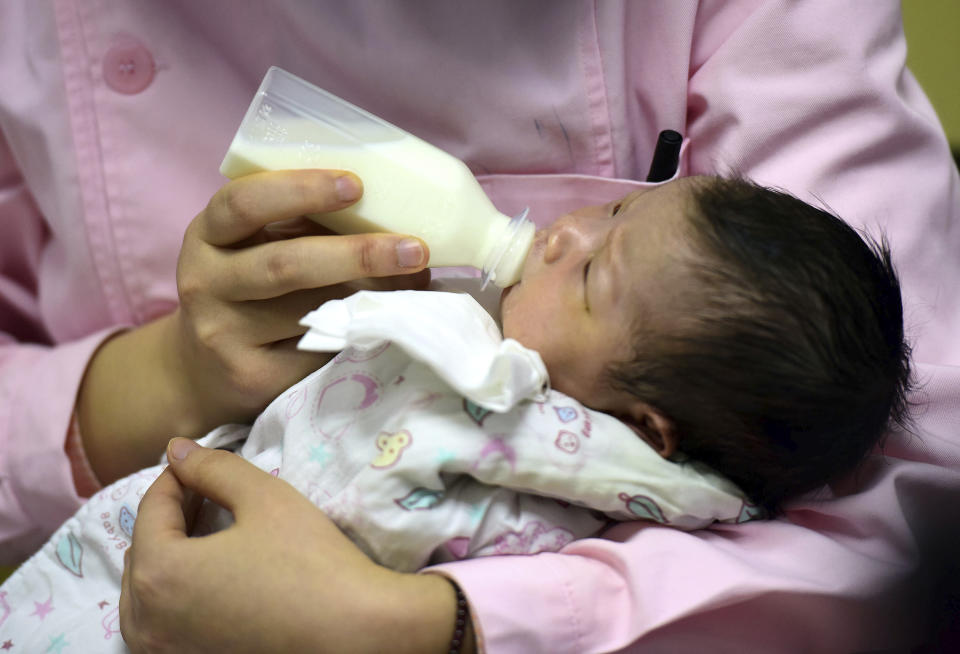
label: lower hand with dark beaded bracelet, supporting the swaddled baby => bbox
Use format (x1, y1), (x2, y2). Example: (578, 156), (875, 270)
(120, 439), (464, 654)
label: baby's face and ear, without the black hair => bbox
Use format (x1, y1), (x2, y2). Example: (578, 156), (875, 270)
(501, 179), (691, 414)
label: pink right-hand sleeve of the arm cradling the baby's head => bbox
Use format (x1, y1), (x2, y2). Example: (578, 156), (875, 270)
(436, 1), (960, 654)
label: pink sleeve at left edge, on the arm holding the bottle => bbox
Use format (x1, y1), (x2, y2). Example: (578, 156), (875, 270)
(0, 131), (109, 564)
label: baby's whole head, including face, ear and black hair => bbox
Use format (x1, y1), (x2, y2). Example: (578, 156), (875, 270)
(502, 177), (909, 509)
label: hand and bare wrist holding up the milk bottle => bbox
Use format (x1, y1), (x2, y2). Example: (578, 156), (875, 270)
(77, 170), (429, 483)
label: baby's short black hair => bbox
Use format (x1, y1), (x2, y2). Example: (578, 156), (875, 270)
(609, 177), (910, 512)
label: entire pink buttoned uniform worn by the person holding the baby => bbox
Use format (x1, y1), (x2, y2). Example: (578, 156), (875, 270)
(0, 0), (960, 652)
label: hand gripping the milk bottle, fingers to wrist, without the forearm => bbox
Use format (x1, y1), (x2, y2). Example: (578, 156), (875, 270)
(176, 170), (429, 432)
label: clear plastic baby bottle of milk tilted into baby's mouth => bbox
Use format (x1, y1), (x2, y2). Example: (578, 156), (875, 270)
(220, 66), (534, 288)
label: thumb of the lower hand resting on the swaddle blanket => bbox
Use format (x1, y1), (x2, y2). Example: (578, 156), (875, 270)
(167, 438), (276, 521)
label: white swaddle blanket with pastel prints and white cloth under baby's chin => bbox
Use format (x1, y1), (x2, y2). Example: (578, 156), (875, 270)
(0, 291), (756, 652)
